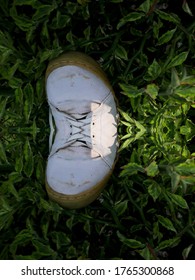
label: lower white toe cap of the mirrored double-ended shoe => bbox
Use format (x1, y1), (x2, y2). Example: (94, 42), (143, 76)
(46, 147), (110, 195)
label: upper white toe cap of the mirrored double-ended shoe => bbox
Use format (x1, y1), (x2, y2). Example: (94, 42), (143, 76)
(46, 65), (110, 108)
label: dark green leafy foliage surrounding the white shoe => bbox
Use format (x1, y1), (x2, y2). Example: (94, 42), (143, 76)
(0, 0), (195, 259)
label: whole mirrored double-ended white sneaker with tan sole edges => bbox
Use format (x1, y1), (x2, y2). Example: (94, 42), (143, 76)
(46, 52), (118, 209)
